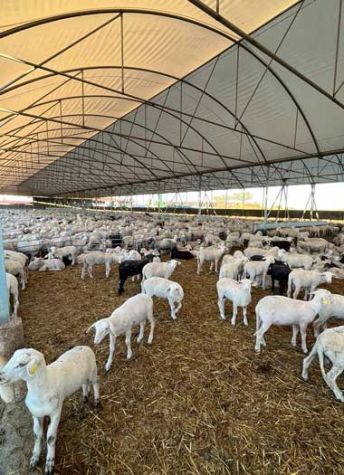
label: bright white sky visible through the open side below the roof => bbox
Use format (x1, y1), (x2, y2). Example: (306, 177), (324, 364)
(0, 182), (344, 210)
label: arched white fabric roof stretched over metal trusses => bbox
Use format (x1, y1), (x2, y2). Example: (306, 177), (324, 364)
(0, 0), (344, 196)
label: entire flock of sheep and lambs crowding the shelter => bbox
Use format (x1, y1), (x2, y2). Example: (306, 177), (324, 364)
(0, 210), (344, 473)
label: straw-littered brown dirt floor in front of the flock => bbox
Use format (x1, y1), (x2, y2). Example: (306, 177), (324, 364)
(20, 261), (344, 475)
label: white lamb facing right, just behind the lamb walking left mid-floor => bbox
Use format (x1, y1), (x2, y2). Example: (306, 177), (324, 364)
(141, 277), (184, 320)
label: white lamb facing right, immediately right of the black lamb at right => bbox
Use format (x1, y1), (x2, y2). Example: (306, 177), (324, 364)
(287, 269), (332, 300)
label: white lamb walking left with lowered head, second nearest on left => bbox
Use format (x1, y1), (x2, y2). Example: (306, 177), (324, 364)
(86, 294), (155, 371)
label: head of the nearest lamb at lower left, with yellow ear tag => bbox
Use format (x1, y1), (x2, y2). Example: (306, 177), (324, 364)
(0, 348), (45, 383)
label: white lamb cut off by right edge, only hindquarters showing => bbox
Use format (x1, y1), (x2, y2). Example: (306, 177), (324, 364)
(302, 326), (344, 402)
